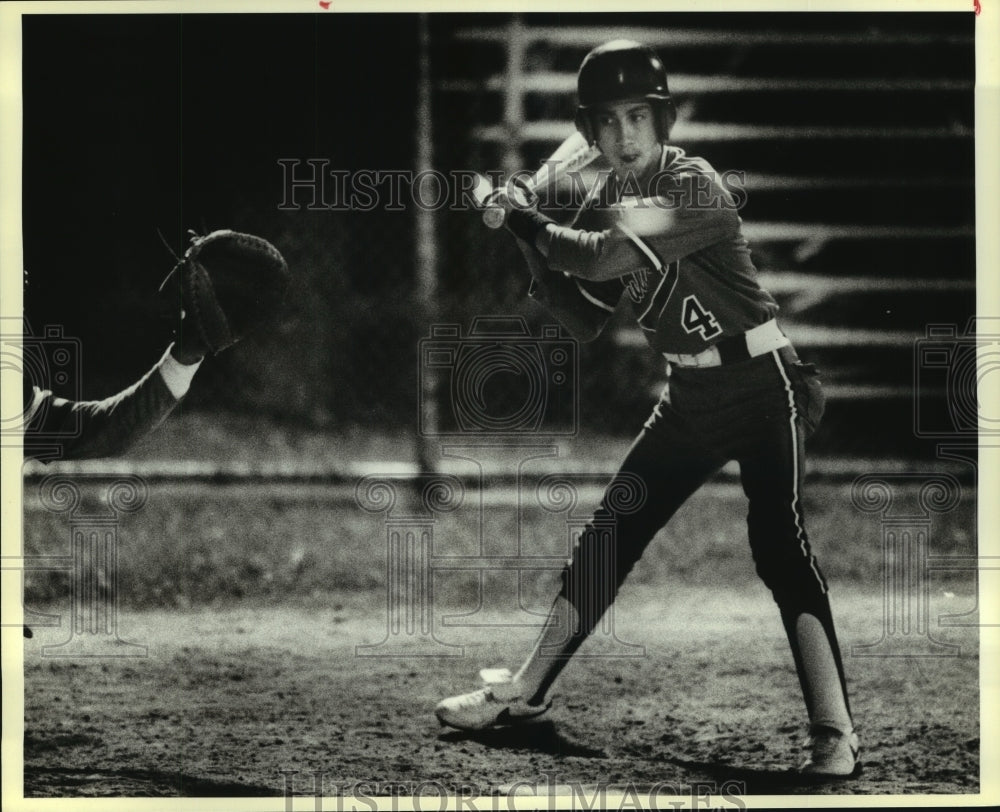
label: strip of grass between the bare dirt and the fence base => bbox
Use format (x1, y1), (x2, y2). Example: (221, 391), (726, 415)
(19, 475), (976, 608)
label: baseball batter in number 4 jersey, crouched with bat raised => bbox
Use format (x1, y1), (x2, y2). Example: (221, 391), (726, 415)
(435, 40), (858, 777)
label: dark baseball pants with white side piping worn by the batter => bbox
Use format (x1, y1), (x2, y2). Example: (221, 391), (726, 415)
(552, 347), (847, 712)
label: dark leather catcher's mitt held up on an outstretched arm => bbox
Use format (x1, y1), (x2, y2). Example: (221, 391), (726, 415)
(160, 229), (291, 353)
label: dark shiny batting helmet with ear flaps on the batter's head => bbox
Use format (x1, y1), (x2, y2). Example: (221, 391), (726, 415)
(576, 39), (677, 144)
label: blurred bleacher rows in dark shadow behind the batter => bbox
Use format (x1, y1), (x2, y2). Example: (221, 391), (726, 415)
(436, 14), (975, 452)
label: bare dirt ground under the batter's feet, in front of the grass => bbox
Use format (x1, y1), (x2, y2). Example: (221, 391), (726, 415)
(24, 586), (980, 809)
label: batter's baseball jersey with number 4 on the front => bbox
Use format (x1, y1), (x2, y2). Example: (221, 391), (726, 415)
(532, 145), (778, 354)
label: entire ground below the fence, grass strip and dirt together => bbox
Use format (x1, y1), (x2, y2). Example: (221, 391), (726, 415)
(13, 454), (980, 808)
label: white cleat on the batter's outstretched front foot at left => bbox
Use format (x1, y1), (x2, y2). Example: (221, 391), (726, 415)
(434, 668), (552, 730)
